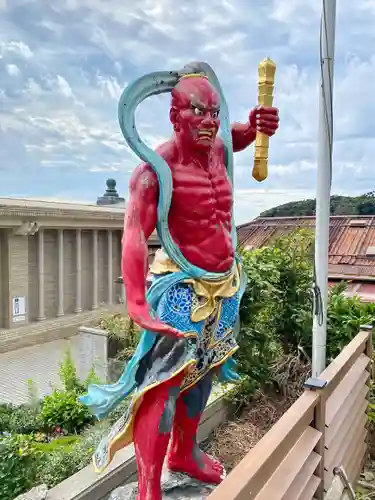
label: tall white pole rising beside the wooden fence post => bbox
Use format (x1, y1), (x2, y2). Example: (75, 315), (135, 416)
(312, 0), (336, 377)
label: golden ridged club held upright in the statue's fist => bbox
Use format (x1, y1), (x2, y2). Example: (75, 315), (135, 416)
(253, 58), (276, 182)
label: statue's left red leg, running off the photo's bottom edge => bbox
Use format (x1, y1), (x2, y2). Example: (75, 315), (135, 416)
(134, 373), (184, 500)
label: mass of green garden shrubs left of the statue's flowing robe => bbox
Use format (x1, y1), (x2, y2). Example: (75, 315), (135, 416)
(0, 352), (109, 500)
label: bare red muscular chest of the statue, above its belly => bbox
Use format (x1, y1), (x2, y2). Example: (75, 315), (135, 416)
(172, 158), (232, 217)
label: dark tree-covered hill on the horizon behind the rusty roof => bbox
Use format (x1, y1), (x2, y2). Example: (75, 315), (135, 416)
(260, 191), (375, 217)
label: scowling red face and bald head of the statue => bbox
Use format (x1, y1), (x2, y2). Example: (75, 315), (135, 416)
(171, 77), (220, 149)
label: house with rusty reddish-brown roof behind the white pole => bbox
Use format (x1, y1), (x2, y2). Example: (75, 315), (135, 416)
(237, 216), (375, 302)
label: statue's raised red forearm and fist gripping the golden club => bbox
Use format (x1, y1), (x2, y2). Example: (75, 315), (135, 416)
(232, 106), (279, 153)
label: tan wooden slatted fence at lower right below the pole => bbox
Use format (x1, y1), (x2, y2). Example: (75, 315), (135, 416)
(209, 327), (372, 500)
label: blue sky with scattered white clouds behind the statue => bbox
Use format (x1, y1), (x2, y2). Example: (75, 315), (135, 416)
(0, 0), (375, 223)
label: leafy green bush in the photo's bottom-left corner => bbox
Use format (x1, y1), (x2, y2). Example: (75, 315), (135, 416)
(0, 435), (38, 500)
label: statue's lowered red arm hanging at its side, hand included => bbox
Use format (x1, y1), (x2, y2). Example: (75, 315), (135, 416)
(121, 164), (179, 336)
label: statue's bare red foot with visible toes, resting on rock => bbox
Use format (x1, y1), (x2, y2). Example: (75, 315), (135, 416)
(168, 446), (226, 484)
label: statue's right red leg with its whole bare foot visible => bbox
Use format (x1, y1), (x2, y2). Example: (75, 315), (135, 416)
(168, 370), (225, 484)
